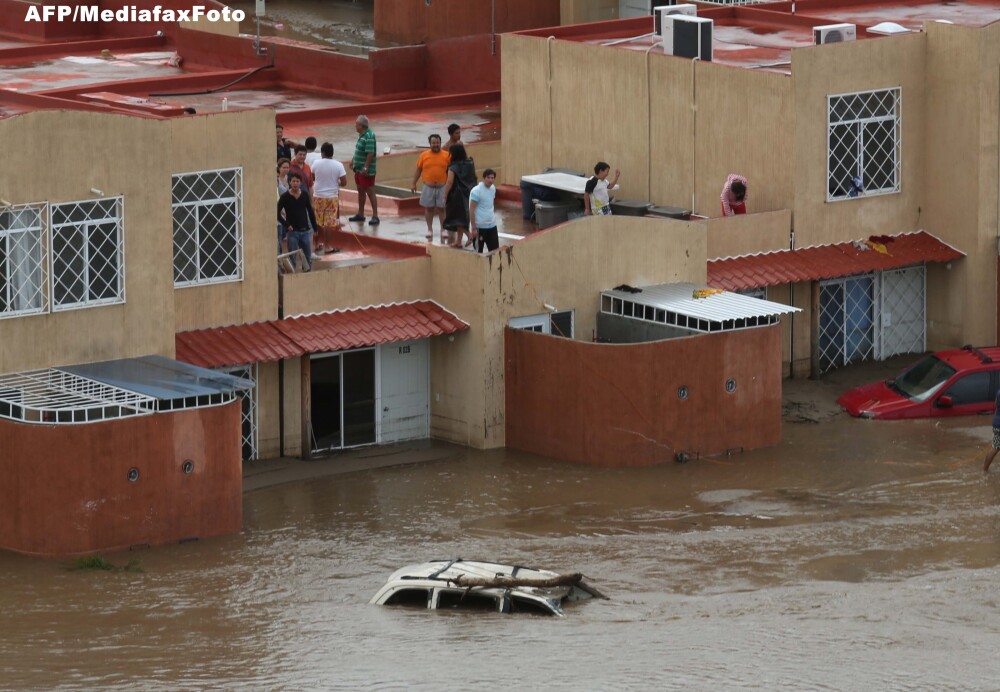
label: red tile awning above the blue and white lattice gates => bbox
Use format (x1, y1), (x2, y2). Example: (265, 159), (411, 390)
(708, 231), (965, 291)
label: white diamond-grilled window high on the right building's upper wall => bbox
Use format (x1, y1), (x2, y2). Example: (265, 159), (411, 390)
(826, 87), (903, 201)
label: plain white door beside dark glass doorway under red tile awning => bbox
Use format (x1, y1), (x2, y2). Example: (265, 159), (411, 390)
(379, 339), (430, 444)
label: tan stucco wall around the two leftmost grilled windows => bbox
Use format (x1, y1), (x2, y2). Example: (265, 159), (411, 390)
(0, 111), (175, 372)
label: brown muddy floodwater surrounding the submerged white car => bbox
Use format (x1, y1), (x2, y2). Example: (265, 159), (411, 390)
(0, 419), (1000, 690)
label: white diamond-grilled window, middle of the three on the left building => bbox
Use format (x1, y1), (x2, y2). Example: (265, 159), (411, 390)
(49, 196), (125, 310)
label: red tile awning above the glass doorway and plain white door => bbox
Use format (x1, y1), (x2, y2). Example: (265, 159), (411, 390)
(174, 300), (469, 368)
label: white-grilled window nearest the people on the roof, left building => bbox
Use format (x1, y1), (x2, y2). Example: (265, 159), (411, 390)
(171, 168), (243, 286)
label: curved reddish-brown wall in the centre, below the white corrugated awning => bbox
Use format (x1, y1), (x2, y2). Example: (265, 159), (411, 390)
(504, 326), (781, 466)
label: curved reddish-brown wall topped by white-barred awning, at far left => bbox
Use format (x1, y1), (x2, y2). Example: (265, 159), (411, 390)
(0, 401), (243, 555)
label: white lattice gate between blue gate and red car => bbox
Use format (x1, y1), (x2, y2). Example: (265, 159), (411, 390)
(878, 265), (927, 359)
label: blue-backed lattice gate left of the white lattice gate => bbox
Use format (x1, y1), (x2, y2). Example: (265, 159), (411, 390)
(819, 274), (878, 372)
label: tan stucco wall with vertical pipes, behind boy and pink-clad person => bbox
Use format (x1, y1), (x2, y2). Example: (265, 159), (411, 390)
(501, 36), (792, 216)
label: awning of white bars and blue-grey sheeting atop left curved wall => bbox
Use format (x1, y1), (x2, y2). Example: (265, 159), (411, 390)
(0, 356), (253, 424)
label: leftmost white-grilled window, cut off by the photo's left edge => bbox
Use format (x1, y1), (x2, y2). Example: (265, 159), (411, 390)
(0, 204), (48, 317)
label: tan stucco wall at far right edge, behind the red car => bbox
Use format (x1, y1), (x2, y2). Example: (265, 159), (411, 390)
(921, 22), (1000, 348)
